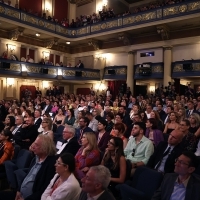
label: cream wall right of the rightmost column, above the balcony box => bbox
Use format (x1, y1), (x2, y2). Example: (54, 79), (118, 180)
(172, 44), (200, 62)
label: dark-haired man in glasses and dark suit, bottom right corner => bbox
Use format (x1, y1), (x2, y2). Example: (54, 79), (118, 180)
(151, 151), (200, 200)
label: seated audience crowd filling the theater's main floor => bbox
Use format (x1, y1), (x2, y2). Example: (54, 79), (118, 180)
(0, 81), (200, 199)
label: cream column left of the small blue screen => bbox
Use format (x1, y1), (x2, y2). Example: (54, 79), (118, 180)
(126, 51), (135, 94)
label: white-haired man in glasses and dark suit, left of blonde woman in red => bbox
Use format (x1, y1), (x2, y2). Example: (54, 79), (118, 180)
(57, 125), (80, 156)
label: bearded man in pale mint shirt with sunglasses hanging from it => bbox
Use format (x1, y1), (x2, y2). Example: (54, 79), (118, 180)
(124, 122), (154, 176)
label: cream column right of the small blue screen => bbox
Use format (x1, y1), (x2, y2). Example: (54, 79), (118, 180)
(163, 46), (172, 87)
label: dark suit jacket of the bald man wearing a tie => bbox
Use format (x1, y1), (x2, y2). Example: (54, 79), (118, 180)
(147, 141), (183, 173)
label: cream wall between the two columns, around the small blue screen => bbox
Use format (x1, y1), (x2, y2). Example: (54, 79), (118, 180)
(135, 48), (163, 64)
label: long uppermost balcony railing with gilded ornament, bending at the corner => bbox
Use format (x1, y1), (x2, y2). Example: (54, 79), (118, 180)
(0, 1), (200, 38)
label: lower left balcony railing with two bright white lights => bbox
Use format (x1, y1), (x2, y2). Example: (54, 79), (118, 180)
(0, 59), (100, 81)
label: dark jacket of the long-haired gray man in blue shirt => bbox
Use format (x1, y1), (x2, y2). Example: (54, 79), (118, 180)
(18, 156), (56, 200)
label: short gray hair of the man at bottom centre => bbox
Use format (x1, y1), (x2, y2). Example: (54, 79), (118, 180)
(90, 165), (111, 190)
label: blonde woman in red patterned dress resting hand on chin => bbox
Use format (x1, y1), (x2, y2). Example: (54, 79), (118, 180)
(74, 132), (100, 181)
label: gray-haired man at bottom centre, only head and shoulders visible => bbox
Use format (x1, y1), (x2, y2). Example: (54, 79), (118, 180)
(79, 165), (115, 200)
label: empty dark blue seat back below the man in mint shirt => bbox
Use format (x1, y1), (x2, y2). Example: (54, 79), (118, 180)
(131, 167), (163, 199)
